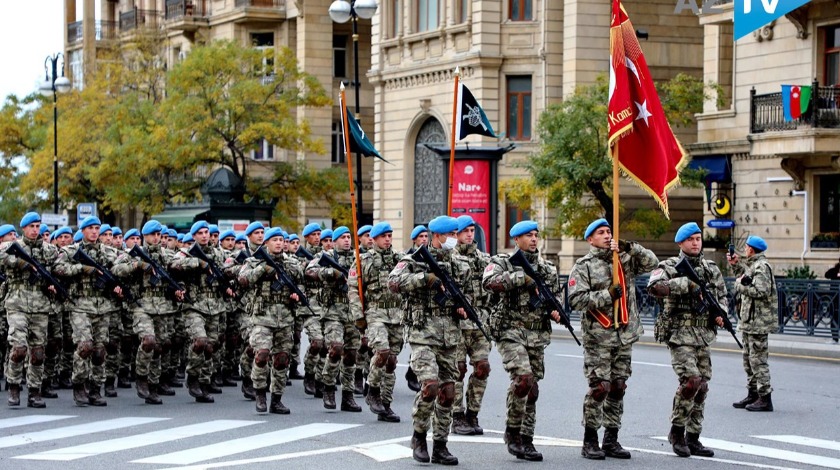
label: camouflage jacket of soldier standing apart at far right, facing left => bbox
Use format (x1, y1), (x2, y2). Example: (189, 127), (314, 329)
(733, 253), (779, 334)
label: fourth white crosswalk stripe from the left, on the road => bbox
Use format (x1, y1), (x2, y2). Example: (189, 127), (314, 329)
(131, 423), (361, 465)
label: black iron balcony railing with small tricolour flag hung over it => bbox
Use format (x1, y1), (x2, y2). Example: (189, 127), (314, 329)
(750, 80), (840, 134)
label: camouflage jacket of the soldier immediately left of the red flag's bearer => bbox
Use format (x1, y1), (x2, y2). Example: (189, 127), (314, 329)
(481, 248), (559, 348)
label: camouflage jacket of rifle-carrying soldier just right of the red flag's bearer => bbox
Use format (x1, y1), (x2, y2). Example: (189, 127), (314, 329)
(648, 252), (727, 346)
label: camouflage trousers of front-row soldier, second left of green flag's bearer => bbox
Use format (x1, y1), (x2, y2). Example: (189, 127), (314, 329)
(248, 325), (294, 395)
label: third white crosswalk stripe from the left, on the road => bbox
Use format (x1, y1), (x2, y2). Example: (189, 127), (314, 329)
(15, 419), (264, 461)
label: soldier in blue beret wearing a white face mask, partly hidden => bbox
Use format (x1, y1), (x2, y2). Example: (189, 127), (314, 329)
(452, 215), (493, 436)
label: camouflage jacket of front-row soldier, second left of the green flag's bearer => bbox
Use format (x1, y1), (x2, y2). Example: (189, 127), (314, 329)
(238, 250), (303, 328)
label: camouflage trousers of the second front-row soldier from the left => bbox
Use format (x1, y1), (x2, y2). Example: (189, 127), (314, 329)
(70, 312), (112, 386)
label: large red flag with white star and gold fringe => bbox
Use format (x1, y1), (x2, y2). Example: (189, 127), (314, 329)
(607, 0), (688, 217)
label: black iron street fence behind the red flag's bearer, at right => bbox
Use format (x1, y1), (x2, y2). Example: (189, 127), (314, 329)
(559, 276), (840, 339)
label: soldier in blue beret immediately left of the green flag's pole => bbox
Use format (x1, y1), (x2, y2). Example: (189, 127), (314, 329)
(306, 227), (362, 412)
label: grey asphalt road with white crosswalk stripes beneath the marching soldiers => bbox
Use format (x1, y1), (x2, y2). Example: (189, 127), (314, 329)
(0, 339), (840, 470)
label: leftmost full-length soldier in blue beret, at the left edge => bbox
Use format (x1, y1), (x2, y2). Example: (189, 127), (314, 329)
(0, 212), (58, 408)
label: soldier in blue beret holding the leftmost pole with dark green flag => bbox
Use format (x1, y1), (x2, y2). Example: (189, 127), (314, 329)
(347, 222), (403, 423)
